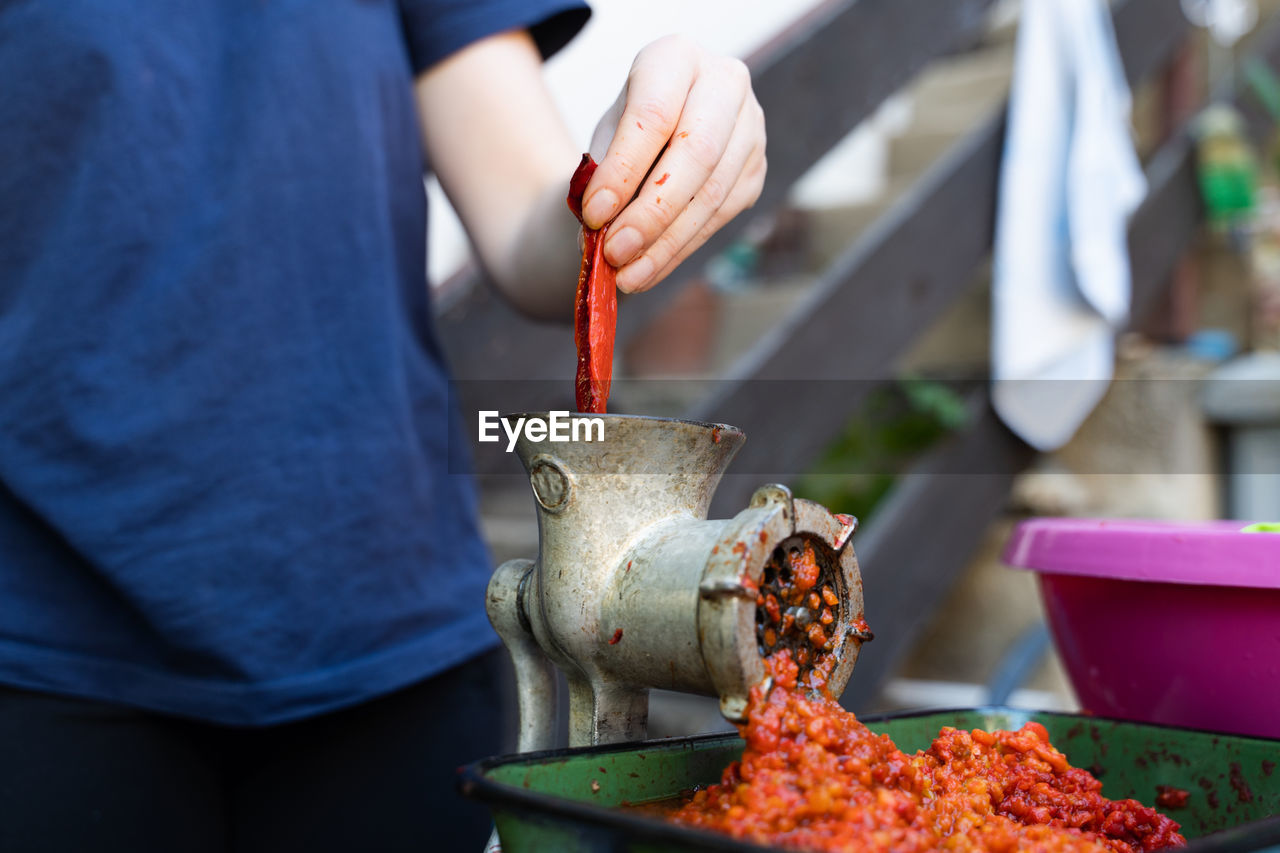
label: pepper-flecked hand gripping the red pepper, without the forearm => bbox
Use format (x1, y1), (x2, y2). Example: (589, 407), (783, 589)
(582, 36), (765, 292)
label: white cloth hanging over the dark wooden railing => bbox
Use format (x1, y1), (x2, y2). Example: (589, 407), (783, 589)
(992, 0), (1147, 451)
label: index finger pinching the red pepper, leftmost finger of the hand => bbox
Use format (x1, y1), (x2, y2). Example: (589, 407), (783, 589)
(582, 40), (698, 228)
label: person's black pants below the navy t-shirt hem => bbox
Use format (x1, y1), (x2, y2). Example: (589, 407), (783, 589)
(0, 652), (509, 853)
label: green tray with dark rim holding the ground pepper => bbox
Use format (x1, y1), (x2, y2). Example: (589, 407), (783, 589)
(461, 708), (1280, 853)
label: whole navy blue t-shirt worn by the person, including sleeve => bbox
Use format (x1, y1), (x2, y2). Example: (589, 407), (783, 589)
(0, 0), (586, 725)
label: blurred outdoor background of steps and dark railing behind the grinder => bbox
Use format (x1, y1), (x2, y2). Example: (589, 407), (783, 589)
(430, 0), (1280, 736)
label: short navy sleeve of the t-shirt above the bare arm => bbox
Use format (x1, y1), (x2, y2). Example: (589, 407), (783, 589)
(399, 0), (591, 74)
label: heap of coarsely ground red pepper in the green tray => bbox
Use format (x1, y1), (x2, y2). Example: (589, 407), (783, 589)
(672, 649), (1187, 853)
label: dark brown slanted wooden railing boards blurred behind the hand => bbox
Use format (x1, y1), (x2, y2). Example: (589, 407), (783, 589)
(440, 0), (1280, 708)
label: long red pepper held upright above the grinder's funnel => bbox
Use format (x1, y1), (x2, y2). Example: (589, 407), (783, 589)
(568, 154), (618, 414)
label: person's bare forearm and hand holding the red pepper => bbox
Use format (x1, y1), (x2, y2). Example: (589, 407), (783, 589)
(417, 31), (764, 320)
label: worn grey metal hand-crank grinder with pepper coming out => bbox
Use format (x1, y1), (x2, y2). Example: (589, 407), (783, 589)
(486, 412), (870, 752)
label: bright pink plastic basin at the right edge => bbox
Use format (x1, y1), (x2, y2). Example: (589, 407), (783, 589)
(1005, 519), (1280, 738)
